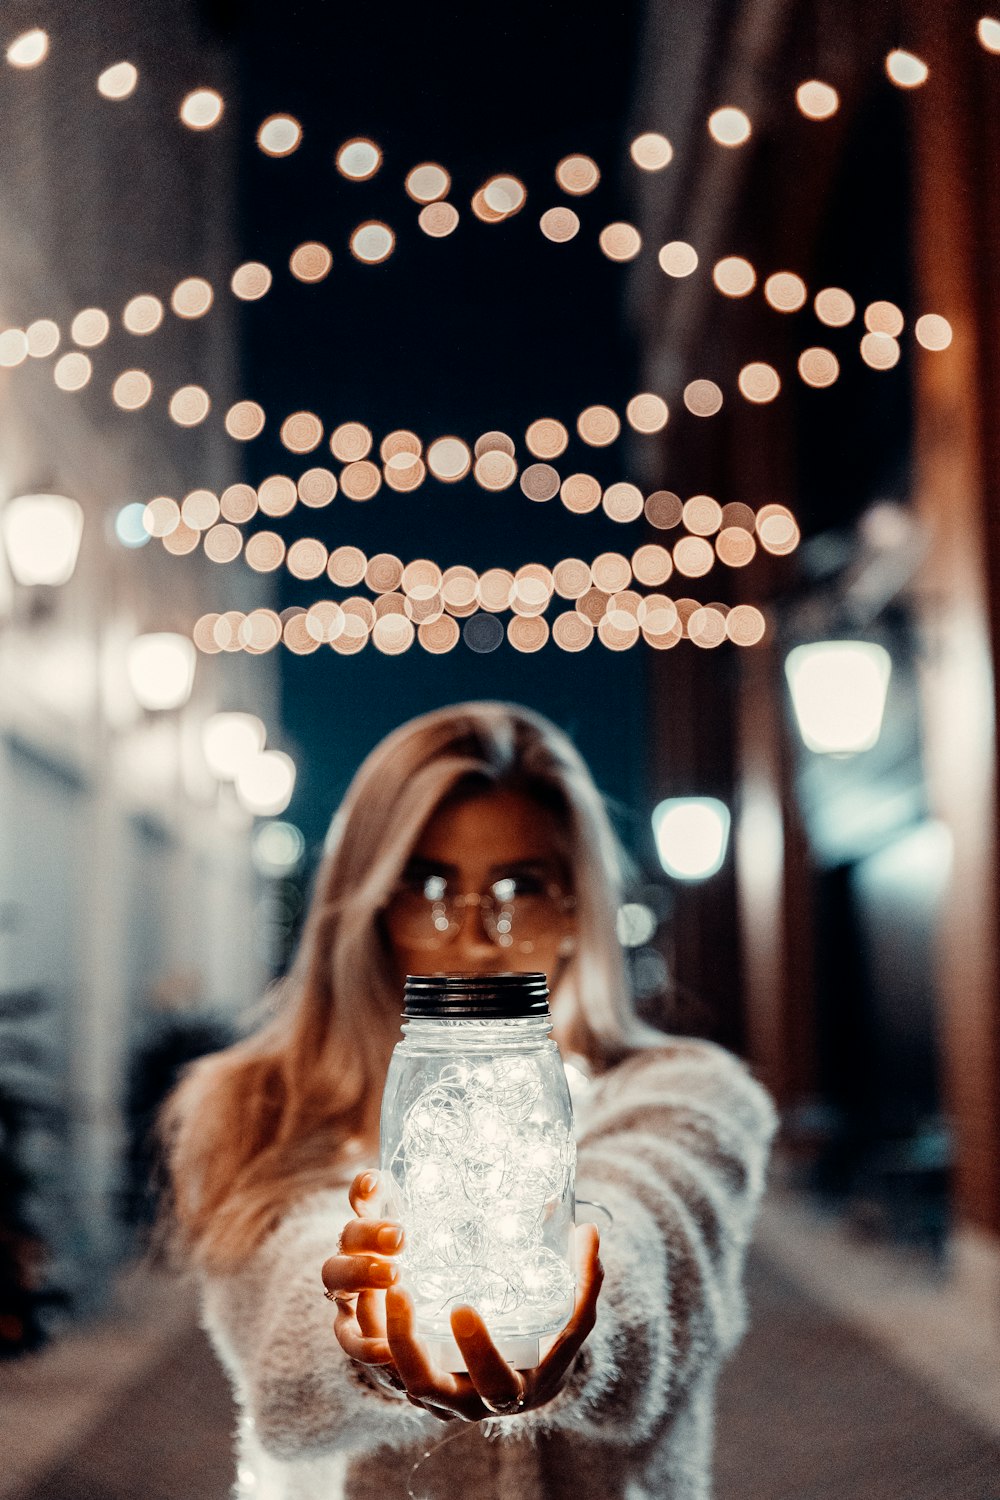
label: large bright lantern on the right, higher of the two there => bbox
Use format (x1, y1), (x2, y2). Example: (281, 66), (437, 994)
(784, 641), (892, 755)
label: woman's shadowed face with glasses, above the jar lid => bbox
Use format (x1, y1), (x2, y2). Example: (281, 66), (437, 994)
(385, 791), (576, 990)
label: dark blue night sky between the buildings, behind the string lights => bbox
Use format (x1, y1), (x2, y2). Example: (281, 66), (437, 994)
(229, 3), (651, 843)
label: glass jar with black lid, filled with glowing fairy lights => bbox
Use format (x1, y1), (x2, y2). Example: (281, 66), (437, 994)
(381, 974), (576, 1371)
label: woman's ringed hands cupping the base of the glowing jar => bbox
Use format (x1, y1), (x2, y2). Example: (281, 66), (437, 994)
(322, 1173), (604, 1422)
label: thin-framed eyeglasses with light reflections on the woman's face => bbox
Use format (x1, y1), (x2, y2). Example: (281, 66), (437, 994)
(385, 875), (576, 953)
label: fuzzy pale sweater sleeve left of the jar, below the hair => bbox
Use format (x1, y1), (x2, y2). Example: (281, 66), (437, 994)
(201, 1191), (436, 1460)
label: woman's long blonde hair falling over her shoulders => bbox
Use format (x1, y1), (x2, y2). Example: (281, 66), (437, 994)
(162, 702), (658, 1271)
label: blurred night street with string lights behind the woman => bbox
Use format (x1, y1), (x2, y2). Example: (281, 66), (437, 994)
(0, 0), (1000, 1500)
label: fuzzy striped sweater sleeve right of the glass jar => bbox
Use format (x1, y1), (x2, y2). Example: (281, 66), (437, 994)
(509, 1038), (778, 1446)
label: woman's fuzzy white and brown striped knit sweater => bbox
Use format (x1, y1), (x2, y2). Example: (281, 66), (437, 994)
(202, 1038), (778, 1500)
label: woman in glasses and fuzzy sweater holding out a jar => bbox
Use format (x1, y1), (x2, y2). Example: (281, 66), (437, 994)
(168, 704), (777, 1500)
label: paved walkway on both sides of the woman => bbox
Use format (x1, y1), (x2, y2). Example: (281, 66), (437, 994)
(0, 1200), (1000, 1500)
